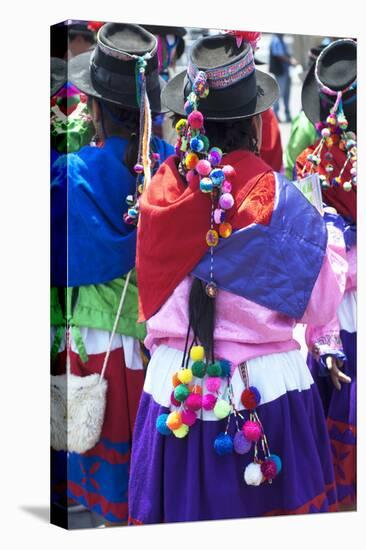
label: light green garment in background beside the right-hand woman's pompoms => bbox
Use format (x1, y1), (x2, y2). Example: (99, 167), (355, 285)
(285, 111), (318, 180)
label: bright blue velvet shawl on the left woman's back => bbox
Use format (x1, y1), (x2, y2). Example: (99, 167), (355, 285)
(51, 137), (174, 286)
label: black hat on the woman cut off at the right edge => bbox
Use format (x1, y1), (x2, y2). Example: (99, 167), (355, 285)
(301, 39), (357, 132)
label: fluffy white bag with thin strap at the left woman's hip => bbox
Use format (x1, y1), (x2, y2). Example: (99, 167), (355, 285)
(51, 272), (131, 454)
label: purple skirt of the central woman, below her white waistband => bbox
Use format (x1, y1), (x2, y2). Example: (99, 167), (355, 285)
(129, 352), (337, 524)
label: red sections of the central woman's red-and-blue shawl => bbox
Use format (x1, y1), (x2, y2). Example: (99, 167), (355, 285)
(136, 151), (275, 321)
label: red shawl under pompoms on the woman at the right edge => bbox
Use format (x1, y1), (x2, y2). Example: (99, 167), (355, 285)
(296, 140), (357, 222)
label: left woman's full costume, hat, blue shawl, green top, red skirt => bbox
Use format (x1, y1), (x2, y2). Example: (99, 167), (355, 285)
(51, 23), (173, 523)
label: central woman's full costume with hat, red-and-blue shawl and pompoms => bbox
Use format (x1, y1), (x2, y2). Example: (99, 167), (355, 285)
(129, 35), (347, 524)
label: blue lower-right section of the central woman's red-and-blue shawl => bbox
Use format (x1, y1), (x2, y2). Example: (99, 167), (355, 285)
(192, 174), (327, 319)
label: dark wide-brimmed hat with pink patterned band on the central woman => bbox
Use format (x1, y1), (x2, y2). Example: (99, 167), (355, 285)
(162, 34), (279, 120)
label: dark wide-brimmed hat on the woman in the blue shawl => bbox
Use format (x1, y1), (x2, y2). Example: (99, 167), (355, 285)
(68, 23), (164, 112)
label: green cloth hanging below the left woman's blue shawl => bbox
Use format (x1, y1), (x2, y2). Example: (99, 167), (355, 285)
(51, 270), (146, 340)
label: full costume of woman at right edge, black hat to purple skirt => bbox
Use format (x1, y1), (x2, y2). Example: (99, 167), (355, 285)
(296, 39), (357, 505)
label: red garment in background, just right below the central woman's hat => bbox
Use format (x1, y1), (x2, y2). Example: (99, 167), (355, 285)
(259, 109), (282, 172)
